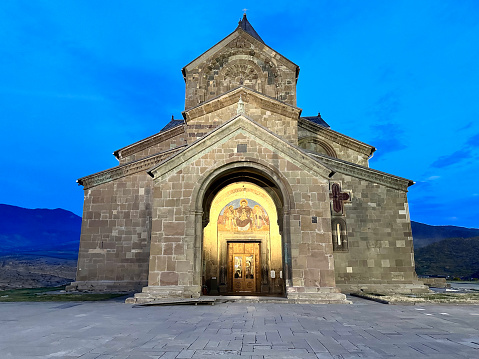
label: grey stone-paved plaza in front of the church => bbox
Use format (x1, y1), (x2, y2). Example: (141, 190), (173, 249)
(0, 298), (479, 359)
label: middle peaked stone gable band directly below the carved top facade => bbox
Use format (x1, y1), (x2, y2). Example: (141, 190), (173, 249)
(183, 86), (302, 124)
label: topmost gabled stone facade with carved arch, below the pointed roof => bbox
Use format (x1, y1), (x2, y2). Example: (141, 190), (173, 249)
(183, 29), (299, 109)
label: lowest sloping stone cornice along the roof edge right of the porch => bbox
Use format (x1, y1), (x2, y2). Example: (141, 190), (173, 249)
(309, 153), (414, 192)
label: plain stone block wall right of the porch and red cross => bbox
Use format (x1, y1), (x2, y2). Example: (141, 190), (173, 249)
(332, 173), (419, 292)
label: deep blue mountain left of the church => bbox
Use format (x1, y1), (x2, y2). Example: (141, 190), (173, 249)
(0, 204), (81, 259)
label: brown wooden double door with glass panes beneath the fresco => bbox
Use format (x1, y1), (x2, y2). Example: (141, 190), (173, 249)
(228, 242), (260, 293)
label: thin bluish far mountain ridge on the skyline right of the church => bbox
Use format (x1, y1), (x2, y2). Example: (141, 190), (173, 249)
(411, 221), (479, 249)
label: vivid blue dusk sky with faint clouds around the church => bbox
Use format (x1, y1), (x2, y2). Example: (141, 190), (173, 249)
(0, 0), (479, 227)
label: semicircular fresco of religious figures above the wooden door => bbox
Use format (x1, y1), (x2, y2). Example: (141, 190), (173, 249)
(218, 198), (269, 232)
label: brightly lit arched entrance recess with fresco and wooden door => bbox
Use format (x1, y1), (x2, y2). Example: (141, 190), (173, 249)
(202, 180), (284, 295)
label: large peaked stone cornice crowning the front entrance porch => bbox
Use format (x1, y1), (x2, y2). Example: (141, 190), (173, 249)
(148, 115), (333, 179)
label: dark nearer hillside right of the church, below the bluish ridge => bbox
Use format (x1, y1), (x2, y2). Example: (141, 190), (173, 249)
(414, 237), (479, 279)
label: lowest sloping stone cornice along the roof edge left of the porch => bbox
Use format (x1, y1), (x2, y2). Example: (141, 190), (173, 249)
(77, 146), (185, 189)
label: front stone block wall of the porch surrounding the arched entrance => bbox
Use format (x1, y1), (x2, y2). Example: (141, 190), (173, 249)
(143, 120), (344, 296)
